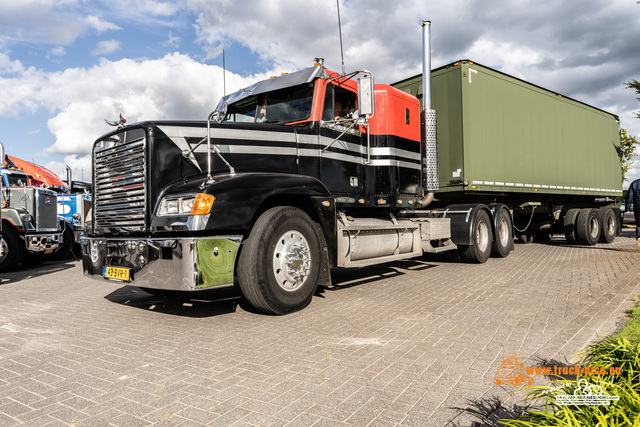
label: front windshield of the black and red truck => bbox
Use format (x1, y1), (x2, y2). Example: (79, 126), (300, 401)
(225, 83), (313, 123)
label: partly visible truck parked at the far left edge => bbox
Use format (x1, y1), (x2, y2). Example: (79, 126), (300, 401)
(0, 143), (63, 272)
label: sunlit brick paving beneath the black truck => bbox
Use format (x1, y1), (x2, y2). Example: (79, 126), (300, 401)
(0, 229), (640, 427)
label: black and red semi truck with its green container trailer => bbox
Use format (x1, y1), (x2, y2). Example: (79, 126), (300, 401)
(82, 21), (622, 314)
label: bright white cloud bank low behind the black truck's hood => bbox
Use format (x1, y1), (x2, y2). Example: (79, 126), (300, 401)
(0, 53), (267, 155)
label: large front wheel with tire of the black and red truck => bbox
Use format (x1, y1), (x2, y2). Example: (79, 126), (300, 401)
(237, 207), (322, 314)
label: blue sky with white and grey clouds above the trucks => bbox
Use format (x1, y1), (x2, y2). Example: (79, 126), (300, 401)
(0, 0), (640, 186)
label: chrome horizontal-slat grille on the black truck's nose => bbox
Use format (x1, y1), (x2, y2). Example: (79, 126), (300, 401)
(94, 134), (147, 231)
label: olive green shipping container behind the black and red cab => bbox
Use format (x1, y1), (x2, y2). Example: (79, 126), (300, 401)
(393, 61), (622, 197)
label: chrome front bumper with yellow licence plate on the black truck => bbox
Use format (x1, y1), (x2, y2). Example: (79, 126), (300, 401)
(81, 235), (242, 291)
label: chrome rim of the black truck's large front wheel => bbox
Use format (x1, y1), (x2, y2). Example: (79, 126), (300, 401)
(273, 230), (311, 292)
